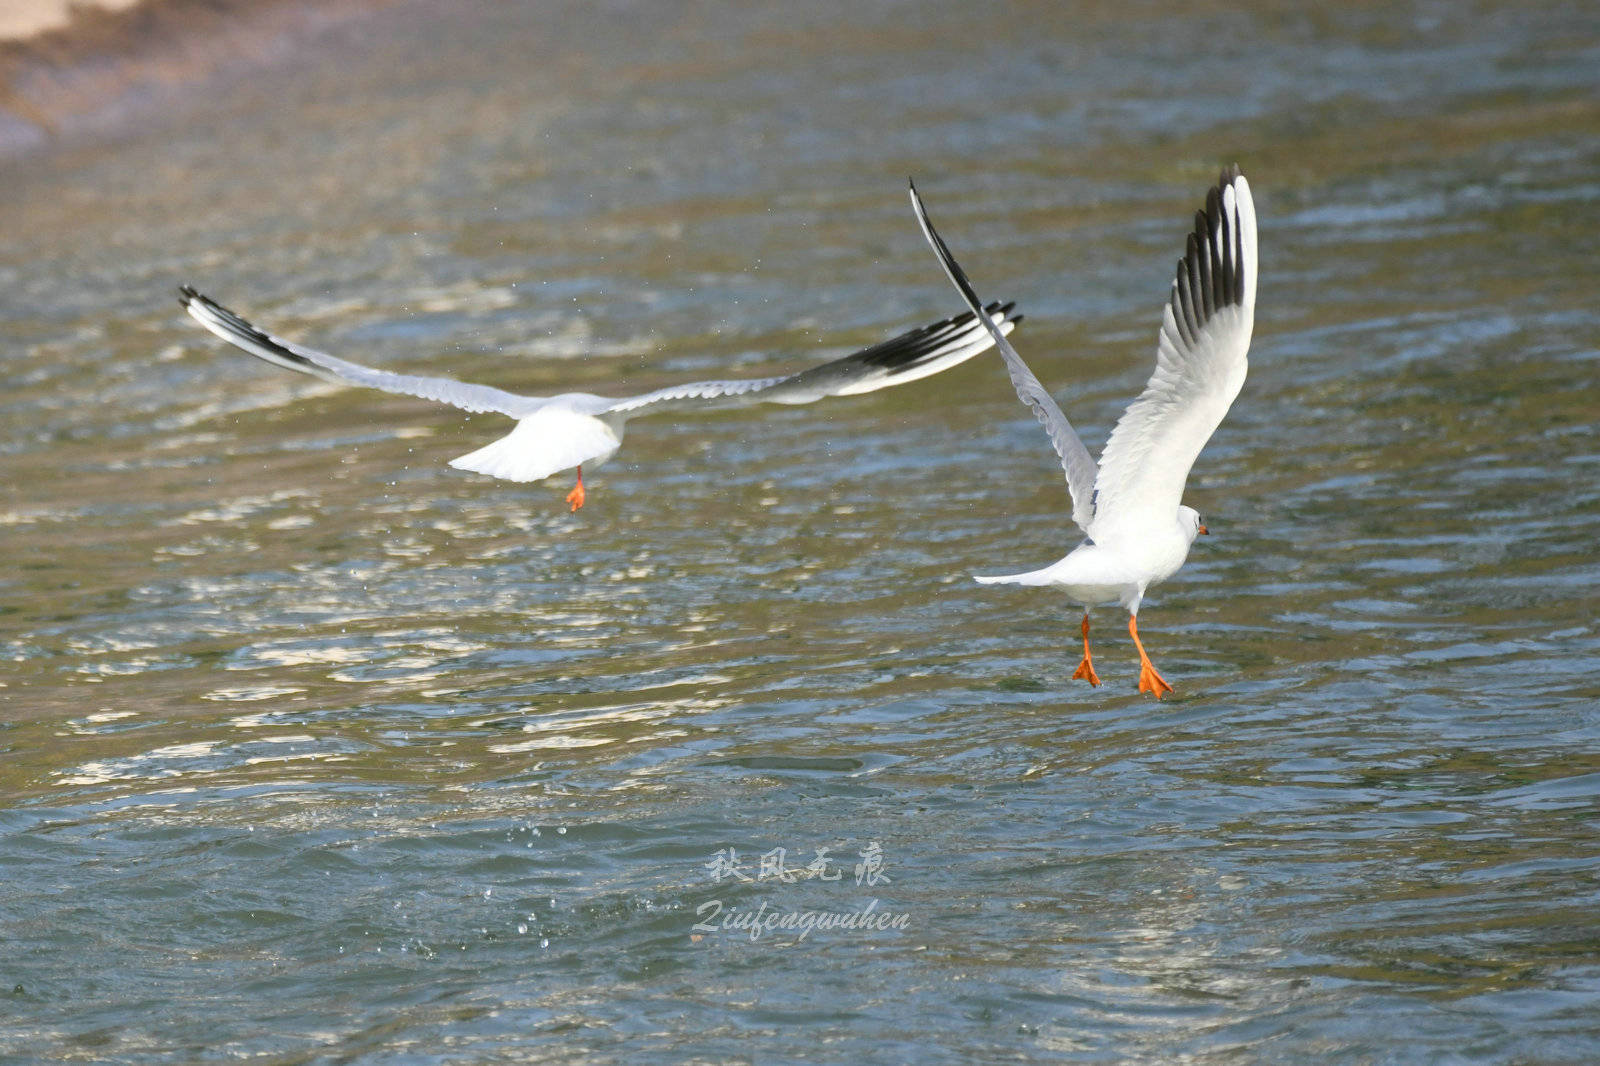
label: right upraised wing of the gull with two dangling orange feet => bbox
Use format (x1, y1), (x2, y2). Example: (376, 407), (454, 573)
(1094, 166), (1256, 525)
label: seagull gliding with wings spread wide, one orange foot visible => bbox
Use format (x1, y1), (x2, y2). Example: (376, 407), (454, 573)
(178, 285), (1022, 511)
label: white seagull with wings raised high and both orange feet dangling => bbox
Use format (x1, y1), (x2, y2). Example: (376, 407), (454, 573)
(910, 166), (1256, 699)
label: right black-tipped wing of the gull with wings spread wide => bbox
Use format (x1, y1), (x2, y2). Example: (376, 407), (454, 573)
(608, 303), (1022, 418)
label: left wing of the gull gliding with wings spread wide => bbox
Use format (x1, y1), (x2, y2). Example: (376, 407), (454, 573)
(178, 285), (546, 418)
